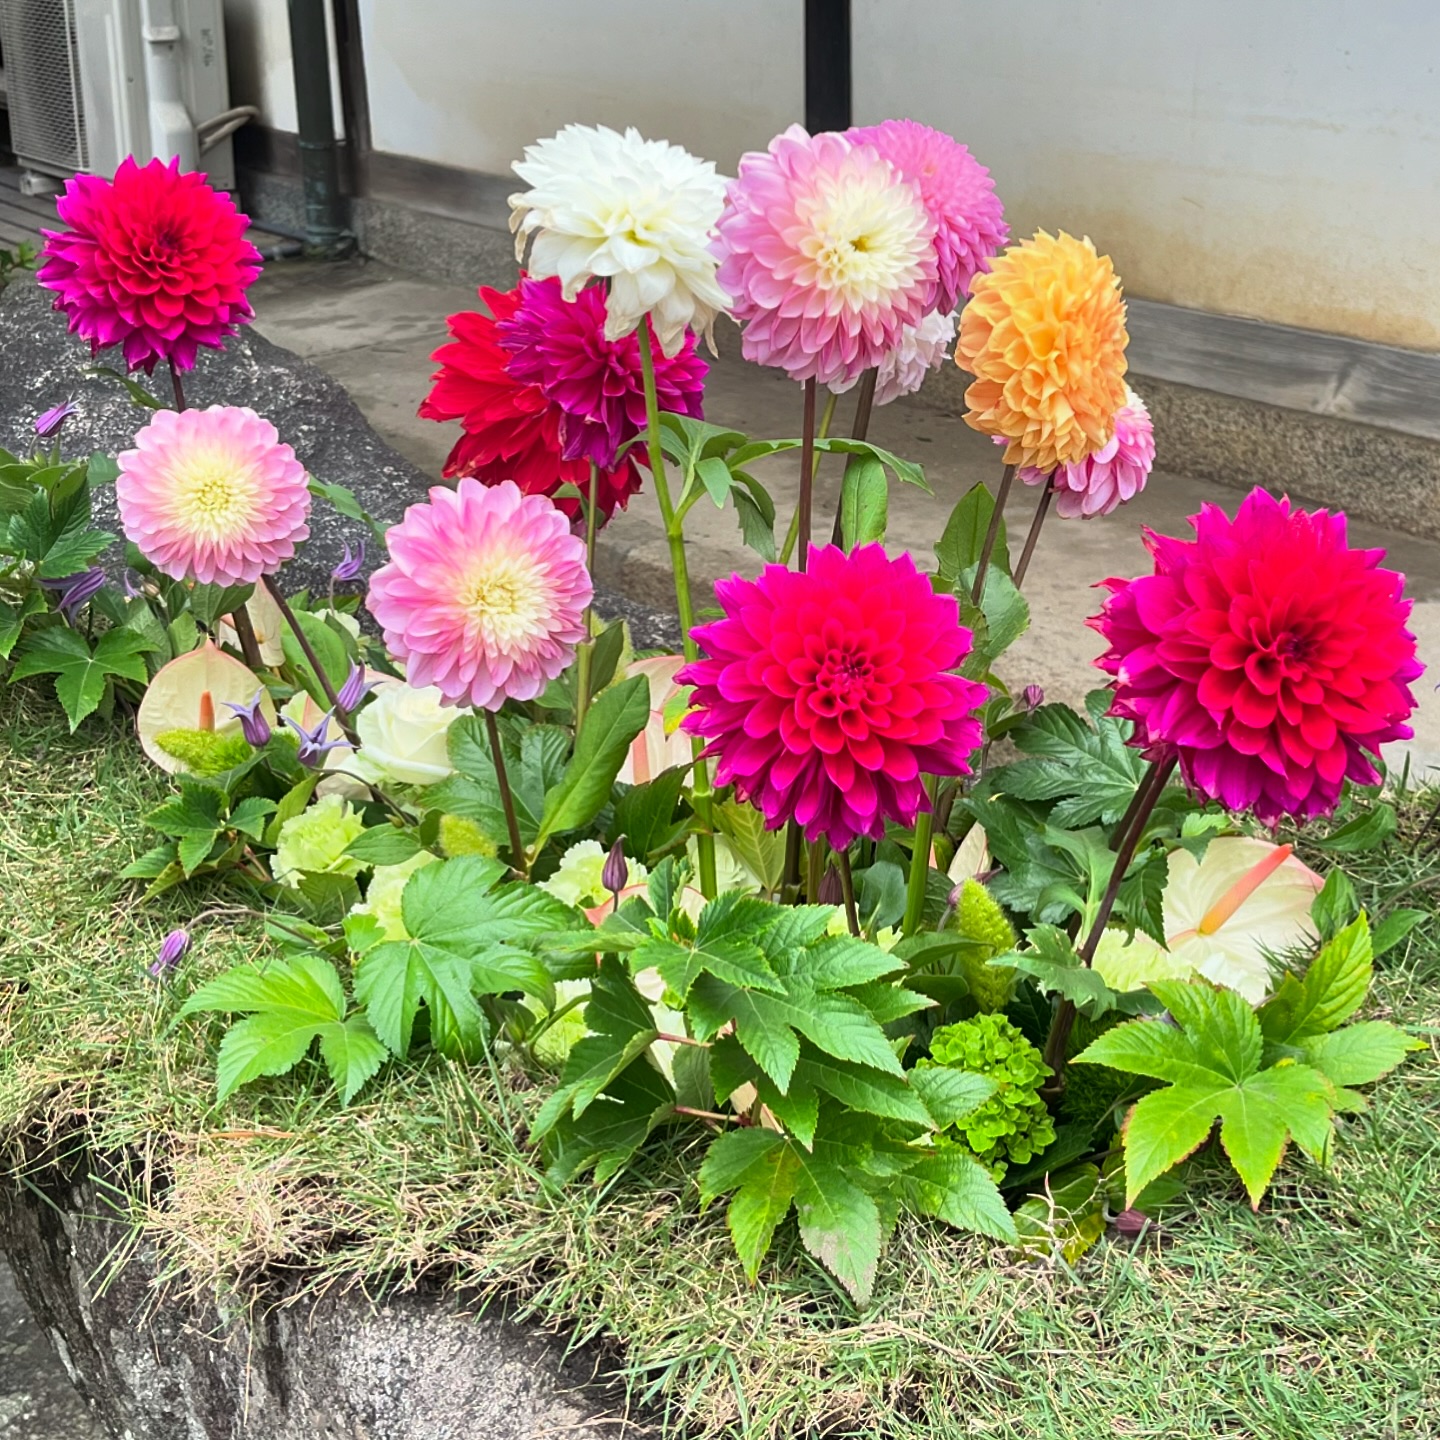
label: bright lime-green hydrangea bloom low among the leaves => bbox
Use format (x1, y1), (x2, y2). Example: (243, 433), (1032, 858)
(919, 1015), (1056, 1181)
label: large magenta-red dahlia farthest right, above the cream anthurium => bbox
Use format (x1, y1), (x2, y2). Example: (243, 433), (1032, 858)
(1090, 490), (1421, 824)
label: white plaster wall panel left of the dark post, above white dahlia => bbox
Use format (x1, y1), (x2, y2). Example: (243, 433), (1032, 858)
(354, 0), (805, 174)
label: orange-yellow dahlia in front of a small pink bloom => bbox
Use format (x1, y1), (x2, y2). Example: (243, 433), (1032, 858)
(955, 230), (1129, 475)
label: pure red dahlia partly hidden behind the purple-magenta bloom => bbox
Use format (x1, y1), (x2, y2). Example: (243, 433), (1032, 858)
(419, 287), (641, 520)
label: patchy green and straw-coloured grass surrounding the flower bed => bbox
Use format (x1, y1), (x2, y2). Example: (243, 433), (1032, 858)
(0, 676), (1440, 1440)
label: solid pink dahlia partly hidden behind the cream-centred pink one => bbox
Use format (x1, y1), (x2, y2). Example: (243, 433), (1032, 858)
(845, 120), (1009, 315)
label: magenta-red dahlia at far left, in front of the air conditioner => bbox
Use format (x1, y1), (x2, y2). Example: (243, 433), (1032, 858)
(39, 158), (261, 374)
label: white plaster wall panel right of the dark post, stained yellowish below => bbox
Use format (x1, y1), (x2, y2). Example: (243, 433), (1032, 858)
(852, 0), (1440, 348)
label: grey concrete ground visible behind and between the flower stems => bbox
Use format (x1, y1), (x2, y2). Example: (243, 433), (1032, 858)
(251, 253), (1440, 783)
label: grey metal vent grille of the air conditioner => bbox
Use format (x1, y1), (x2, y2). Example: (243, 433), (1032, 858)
(0, 0), (88, 174)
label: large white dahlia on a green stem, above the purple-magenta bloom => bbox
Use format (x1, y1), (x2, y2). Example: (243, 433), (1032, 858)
(510, 125), (729, 356)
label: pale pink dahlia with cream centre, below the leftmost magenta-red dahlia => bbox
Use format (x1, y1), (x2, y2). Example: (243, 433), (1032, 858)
(115, 405), (310, 585)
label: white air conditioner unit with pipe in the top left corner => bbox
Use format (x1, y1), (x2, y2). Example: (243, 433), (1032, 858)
(0, 0), (239, 192)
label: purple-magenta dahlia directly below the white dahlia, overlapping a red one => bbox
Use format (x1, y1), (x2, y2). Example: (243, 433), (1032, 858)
(495, 276), (710, 469)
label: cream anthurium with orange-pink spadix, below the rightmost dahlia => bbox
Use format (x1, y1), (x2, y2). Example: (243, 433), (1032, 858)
(1094, 835), (1323, 1005)
